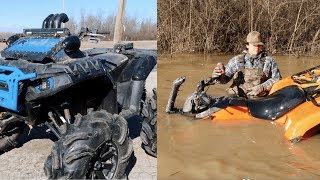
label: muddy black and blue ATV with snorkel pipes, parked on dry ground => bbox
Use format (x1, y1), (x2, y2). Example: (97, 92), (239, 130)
(0, 13), (157, 179)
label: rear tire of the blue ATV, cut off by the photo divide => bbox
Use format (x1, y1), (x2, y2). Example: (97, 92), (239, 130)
(140, 89), (157, 157)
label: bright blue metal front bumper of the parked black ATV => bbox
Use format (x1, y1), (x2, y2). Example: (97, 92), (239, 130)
(0, 65), (37, 111)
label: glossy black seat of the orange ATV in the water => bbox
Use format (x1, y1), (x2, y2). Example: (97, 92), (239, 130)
(247, 85), (306, 120)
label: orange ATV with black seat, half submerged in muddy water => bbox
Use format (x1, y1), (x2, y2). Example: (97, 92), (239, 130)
(166, 66), (320, 143)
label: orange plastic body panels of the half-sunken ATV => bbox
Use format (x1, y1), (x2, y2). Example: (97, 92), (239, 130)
(203, 74), (320, 142)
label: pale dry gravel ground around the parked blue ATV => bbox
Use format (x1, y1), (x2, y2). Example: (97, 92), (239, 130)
(0, 41), (157, 180)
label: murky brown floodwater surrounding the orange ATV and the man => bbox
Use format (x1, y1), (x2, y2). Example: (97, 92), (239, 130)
(158, 55), (320, 179)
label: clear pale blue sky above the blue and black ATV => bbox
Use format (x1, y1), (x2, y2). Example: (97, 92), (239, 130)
(0, 0), (157, 33)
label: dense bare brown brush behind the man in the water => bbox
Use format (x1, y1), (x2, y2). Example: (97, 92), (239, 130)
(157, 0), (320, 54)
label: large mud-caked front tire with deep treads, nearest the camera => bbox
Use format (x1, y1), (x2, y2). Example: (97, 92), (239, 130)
(44, 110), (133, 179)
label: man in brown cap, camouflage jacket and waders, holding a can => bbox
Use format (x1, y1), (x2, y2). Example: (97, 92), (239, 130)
(212, 31), (281, 97)
